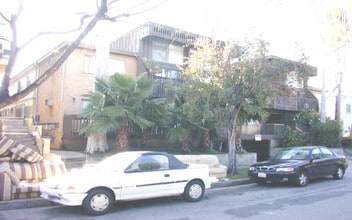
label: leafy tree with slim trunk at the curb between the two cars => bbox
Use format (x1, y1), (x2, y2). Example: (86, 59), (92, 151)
(184, 39), (296, 174)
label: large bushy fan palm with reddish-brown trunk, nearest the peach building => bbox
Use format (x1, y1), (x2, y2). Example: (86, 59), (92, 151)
(81, 74), (167, 150)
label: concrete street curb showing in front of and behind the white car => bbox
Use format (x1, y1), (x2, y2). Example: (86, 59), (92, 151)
(0, 178), (253, 211)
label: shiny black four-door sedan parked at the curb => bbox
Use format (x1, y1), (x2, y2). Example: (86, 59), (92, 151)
(248, 146), (348, 186)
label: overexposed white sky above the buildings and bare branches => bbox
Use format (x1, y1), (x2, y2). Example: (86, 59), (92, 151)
(0, 0), (330, 68)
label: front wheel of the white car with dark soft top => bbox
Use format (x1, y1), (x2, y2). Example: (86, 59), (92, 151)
(82, 189), (114, 215)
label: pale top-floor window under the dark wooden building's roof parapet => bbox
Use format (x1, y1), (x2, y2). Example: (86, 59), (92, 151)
(152, 42), (183, 65)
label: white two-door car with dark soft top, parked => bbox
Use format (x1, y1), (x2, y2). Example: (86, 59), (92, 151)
(40, 151), (217, 215)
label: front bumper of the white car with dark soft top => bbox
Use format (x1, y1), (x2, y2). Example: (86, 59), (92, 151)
(40, 186), (87, 206)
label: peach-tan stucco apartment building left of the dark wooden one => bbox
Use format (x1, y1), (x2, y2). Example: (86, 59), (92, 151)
(1, 42), (137, 149)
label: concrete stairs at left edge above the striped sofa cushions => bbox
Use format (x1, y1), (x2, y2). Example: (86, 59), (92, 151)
(0, 117), (37, 151)
